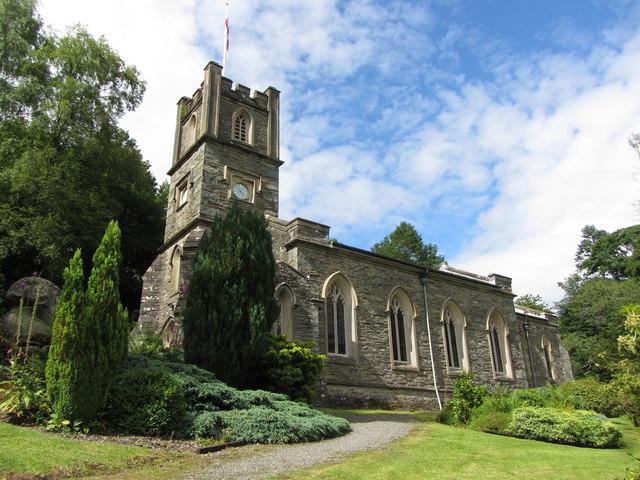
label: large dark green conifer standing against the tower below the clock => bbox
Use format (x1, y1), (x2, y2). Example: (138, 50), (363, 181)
(183, 204), (278, 388)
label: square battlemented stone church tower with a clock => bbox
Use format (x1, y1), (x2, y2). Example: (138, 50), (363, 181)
(139, 62), (282, 342)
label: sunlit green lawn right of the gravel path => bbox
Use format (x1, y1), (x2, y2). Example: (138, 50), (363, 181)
(270, 415), (640, 480)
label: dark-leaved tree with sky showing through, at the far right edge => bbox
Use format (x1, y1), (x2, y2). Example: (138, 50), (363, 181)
(576, 225), (640, 280)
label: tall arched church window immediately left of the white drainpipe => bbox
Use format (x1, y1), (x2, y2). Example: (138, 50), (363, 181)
(387, 288), (418, 366)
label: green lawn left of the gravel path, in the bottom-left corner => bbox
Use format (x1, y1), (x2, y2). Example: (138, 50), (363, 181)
(0, 422), (190, 479)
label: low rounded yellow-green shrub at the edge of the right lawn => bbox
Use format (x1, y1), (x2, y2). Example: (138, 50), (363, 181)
(504, 407), (622, 448)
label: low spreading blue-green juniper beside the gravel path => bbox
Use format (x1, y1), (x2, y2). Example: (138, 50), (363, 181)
(115, 355), (349, 443)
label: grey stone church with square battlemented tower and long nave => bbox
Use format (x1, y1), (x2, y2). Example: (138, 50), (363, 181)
(139, 62), (572, 409)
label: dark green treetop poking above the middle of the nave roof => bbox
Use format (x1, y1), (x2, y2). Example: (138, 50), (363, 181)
(371, 222), (444, 269)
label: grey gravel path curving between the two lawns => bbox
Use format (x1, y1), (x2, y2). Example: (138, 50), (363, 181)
(180, 414), (416, 480)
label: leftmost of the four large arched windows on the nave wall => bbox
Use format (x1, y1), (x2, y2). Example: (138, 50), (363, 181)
(323, 274), (357, 356)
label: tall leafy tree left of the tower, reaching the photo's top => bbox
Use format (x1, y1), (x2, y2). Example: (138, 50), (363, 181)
(0, 0), (165, 316)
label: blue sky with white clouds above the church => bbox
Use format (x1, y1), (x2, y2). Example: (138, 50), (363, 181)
(39, 0), (640, 304)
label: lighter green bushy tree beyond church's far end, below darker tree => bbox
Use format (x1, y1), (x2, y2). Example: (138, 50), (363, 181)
(557, 276), (640, 381)
